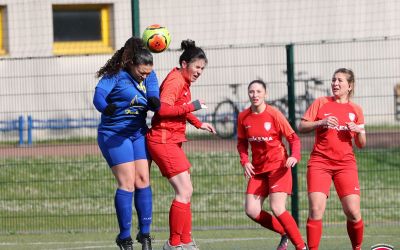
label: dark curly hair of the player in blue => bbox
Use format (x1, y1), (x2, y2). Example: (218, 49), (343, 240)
(96, 37), (153, 77)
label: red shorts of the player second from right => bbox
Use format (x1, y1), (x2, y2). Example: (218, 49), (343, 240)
(246, 167), (292, 197)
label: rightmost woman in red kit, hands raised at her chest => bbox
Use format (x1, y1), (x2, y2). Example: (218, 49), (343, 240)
(299, 68), (366, 249)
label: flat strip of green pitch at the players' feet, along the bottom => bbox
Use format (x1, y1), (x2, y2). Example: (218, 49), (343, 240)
(0, 228), (400, 250)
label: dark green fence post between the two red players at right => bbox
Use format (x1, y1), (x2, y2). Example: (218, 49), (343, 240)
(286, 44), (299, 225)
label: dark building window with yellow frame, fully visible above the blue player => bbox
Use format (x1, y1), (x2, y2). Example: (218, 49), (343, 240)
(53, 4), (113, 55)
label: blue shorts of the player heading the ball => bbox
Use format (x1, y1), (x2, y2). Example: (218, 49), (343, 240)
(97, 132), (150, 167)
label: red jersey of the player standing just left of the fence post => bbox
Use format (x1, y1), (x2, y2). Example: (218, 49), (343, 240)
(237, 105), (300, 174)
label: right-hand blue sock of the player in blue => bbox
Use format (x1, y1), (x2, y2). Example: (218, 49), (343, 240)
(135, 186), (153, 234)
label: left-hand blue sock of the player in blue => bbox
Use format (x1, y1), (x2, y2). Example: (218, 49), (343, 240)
(114, 189), (133, 240)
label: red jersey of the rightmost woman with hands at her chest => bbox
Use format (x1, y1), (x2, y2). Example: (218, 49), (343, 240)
(302, 97), (364, 164)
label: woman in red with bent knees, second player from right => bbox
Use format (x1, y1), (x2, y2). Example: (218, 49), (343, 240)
(237, 80), (307, 250)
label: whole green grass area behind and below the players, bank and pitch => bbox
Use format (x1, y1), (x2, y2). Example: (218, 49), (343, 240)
(0, 149), (400, 249)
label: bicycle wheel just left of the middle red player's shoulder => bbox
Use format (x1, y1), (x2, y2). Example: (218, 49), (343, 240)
(213, 100), (239, 139)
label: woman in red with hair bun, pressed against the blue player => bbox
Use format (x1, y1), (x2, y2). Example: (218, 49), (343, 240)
(147, 40), (215, 250)
